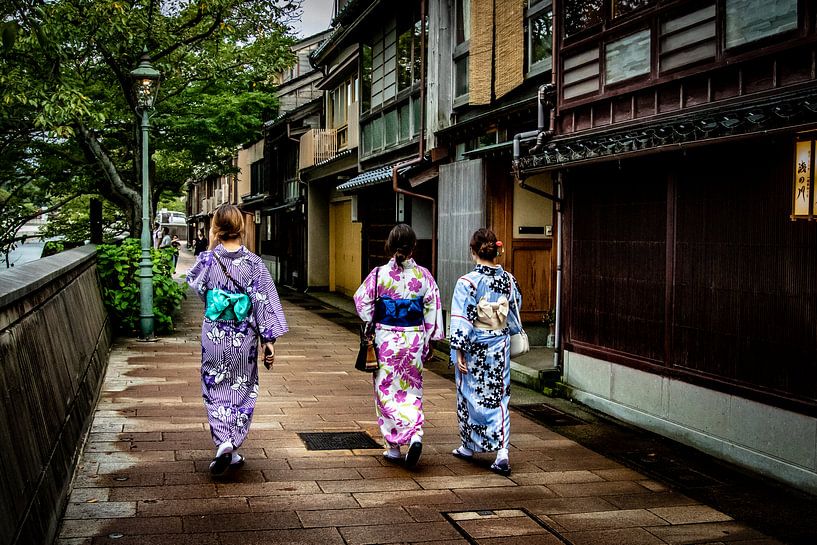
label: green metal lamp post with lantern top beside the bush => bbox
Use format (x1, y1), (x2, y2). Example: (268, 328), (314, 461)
(131, 47), (160, 341)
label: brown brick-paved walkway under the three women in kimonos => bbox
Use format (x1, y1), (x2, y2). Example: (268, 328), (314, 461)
(58, 278), (778, 545)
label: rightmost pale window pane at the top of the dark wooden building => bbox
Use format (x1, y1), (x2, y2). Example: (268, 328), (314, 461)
(726, 0), (797, 48)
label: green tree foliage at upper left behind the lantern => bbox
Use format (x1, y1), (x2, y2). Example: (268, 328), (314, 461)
(0, 0), (301, 260)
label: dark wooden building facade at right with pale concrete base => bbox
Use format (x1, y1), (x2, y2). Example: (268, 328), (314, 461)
(518, 0), (817, 492)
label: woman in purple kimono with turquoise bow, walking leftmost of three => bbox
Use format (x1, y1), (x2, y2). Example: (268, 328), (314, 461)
(187, 205), (288, 476)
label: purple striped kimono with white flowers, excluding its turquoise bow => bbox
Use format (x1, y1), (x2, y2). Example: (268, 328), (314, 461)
(187, 245), (288, 448)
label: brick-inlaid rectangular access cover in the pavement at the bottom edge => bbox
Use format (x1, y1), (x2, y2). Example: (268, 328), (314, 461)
(443, 509), (572, 545)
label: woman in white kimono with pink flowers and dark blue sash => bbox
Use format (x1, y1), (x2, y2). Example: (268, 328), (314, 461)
(354, 224), (444, 467)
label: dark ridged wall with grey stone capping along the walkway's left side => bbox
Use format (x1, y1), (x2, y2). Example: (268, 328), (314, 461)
(0, 247), (111, 545)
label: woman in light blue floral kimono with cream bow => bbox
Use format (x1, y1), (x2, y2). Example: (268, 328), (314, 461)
(451, 229), (522, 476)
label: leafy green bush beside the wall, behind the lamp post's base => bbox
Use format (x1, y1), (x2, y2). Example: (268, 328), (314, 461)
(97, 238), (187, 335)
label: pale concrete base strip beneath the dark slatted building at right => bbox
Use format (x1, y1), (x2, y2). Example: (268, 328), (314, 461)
(564, 351), (817, 494)
